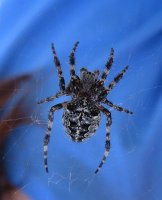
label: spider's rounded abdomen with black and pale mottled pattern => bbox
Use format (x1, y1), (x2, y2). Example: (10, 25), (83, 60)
(62, 101), (100, 142)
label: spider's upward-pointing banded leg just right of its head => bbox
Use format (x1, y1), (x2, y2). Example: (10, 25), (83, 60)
(100, 48), (114, 84)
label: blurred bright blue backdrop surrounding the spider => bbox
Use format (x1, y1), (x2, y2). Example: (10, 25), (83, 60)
(0, 0), (162, 200)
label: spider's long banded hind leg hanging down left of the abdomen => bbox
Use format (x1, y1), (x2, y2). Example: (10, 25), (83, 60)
(44, 102), (68, 172)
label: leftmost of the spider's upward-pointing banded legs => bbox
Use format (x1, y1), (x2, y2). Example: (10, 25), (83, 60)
(51, 43), (65, 91)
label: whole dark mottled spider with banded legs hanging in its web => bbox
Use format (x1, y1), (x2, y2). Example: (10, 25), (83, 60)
(38, 42), (133, 173)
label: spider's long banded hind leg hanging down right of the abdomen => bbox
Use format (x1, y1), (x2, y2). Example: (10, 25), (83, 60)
(95, 105), (112, 174)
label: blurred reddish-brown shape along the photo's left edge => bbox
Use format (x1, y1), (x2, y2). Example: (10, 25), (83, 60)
(0, 74), (32, 200)
